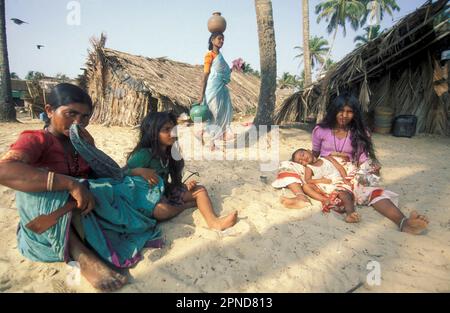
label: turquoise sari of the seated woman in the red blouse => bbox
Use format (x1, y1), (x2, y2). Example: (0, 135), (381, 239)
(16, 126), (164, 267)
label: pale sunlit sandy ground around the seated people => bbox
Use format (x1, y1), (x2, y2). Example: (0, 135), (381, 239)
(0, 121), (450, 292)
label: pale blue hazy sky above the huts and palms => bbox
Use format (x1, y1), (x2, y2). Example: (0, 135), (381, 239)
(6, 0), (425, 78)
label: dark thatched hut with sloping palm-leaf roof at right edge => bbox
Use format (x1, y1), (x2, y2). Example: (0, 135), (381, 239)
(275, 0), (450, 134)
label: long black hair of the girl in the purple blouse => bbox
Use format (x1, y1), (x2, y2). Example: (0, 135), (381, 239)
(319, 92), (378, 162)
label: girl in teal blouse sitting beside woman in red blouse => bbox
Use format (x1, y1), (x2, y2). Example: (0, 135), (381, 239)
(127, 112), (237, 230)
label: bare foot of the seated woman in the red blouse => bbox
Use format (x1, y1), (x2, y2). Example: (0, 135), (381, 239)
(78, 254), (128, 291)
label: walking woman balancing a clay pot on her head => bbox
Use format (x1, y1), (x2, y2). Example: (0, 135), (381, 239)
(199, 32), (233, 150)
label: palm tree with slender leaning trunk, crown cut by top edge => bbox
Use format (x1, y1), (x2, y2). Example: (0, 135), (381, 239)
(315, 0), (366, 75)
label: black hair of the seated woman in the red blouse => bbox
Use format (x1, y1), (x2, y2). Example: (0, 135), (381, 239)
(44, 83), (92, 128)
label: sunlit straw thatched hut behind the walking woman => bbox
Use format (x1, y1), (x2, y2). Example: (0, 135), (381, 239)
(80, 34), (260, 126)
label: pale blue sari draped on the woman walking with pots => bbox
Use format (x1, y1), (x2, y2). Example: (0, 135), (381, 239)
(203, 53), (233, 140)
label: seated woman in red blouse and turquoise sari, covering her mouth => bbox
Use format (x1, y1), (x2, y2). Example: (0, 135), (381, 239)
(0, 84), (168, 291)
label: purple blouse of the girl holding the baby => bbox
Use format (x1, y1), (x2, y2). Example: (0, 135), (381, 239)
(312, 125), (368, 164)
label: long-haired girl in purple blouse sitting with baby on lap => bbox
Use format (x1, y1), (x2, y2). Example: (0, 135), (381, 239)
(312, 93), (428, 234)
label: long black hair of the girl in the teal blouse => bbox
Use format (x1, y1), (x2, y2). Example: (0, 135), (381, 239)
(127, 112), (184, 186)
